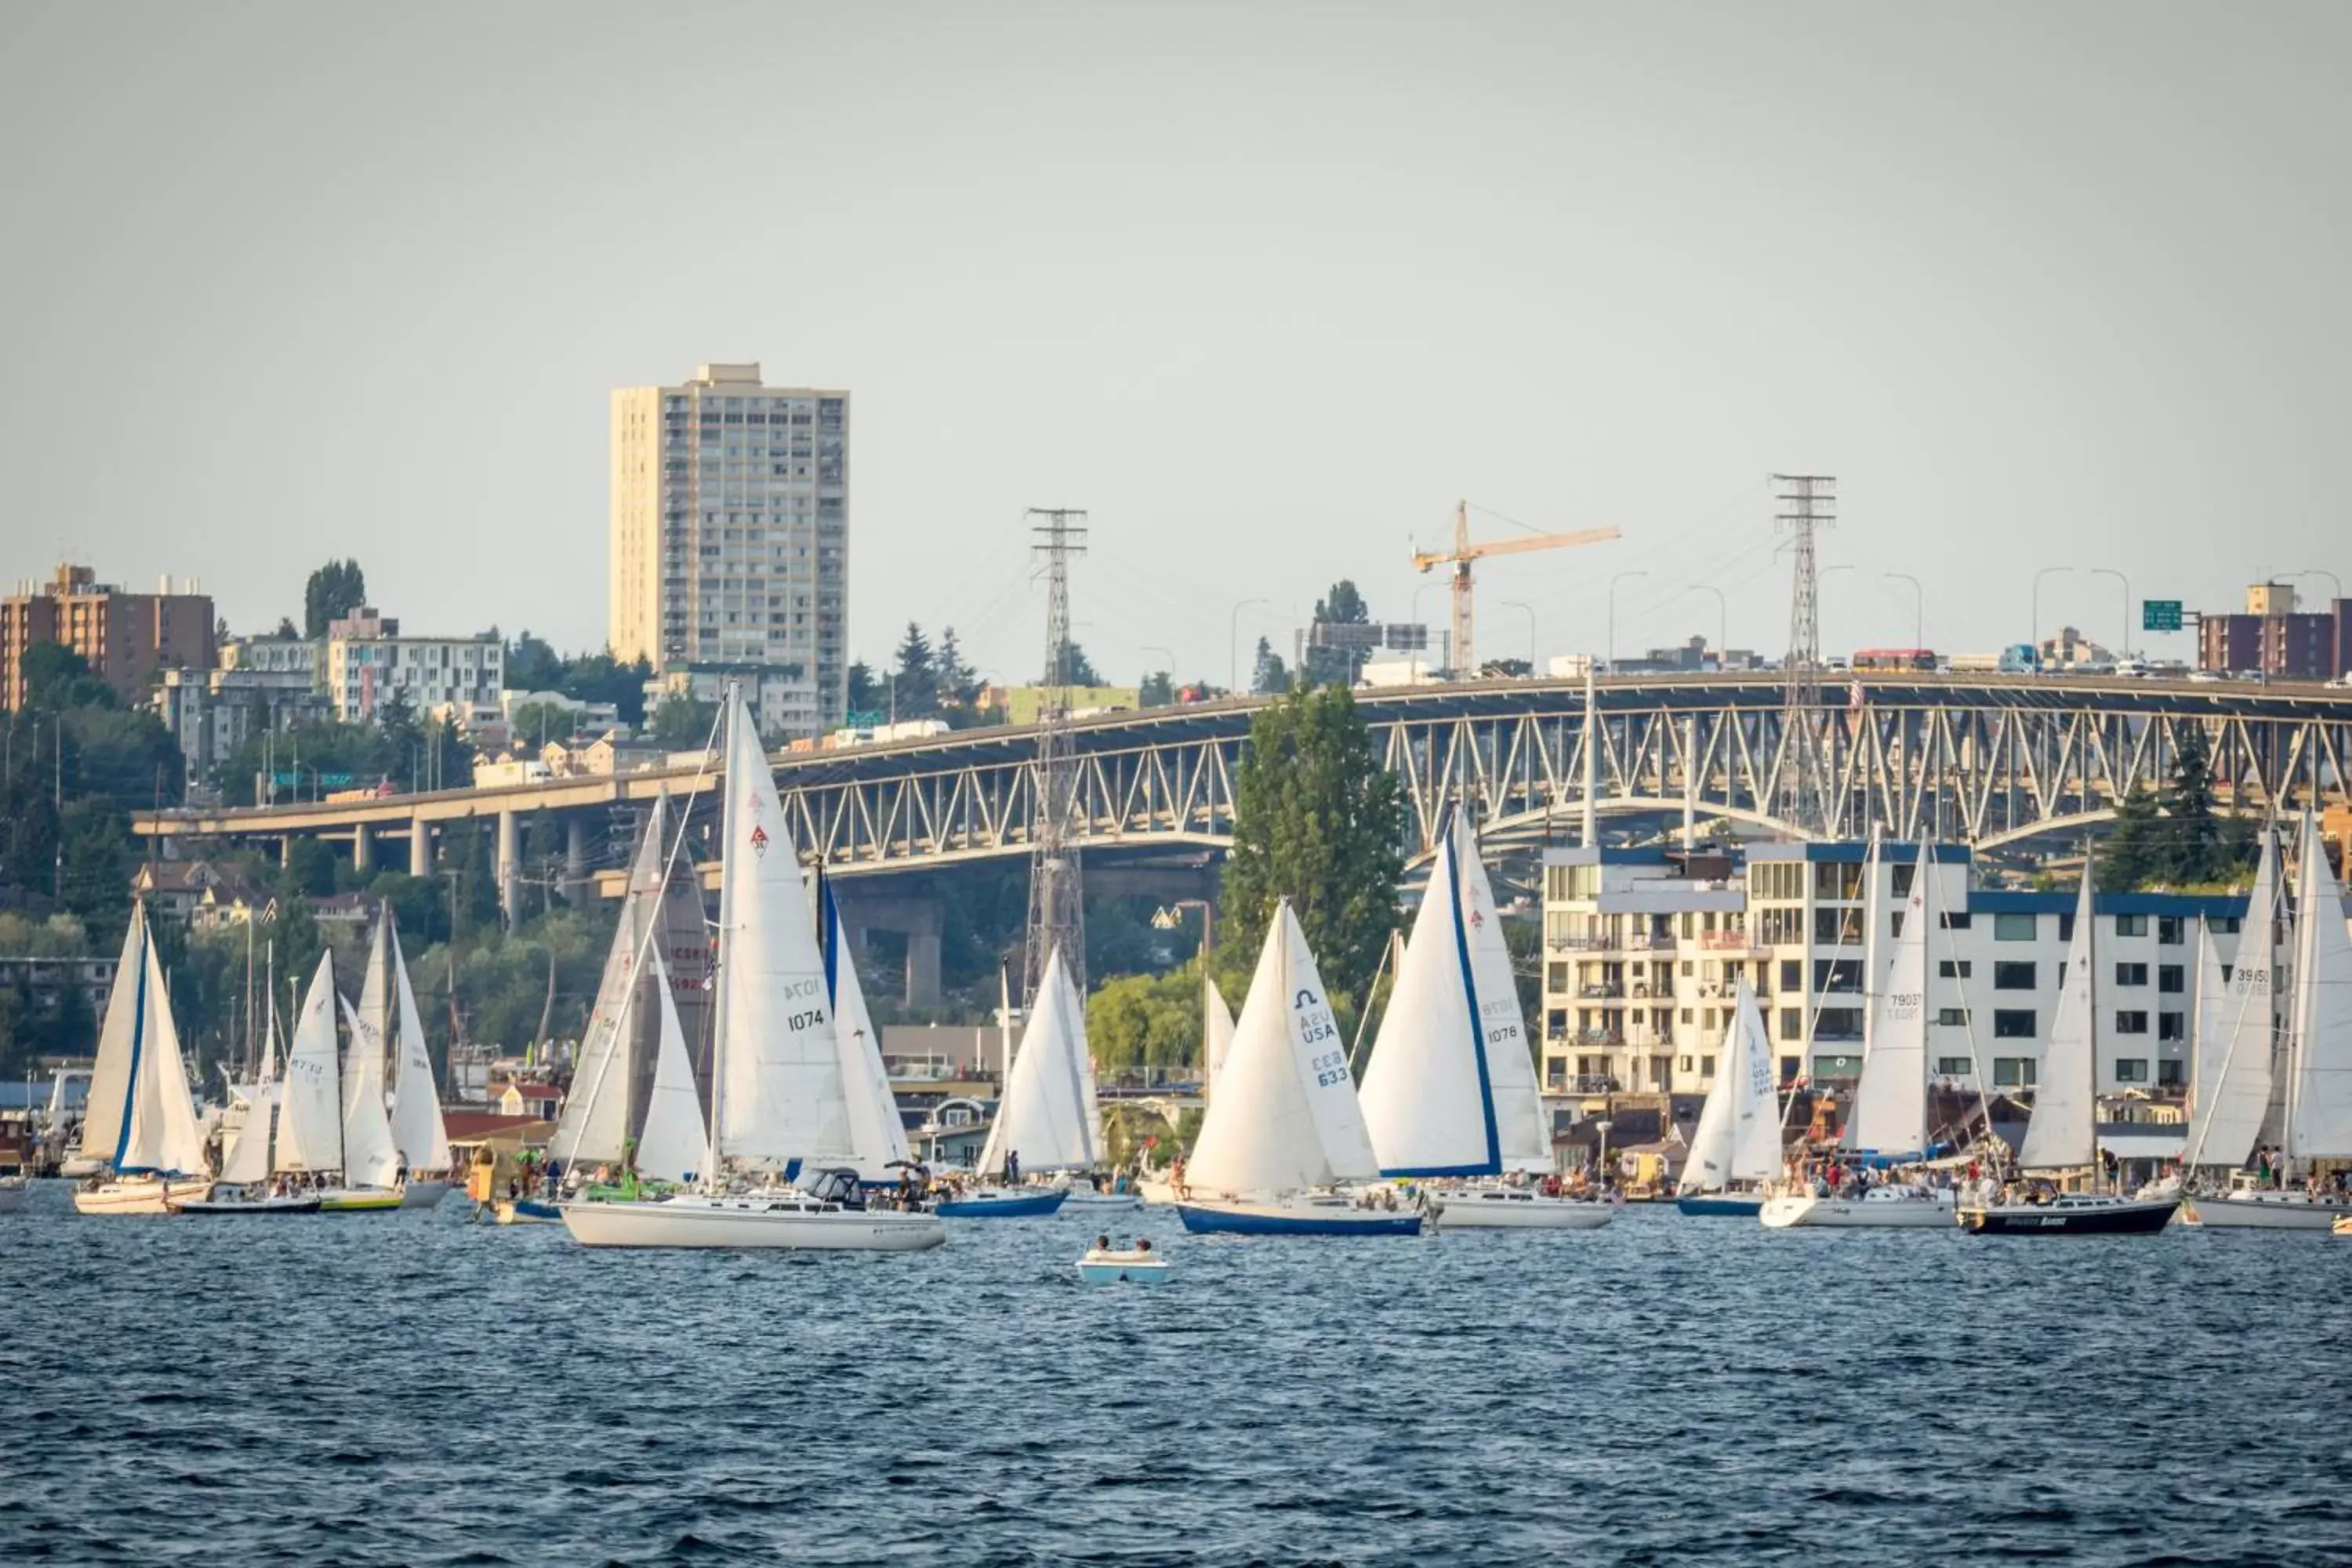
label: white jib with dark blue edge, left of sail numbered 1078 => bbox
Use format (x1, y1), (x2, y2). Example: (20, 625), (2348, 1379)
(1355, 829), (1503, 1175)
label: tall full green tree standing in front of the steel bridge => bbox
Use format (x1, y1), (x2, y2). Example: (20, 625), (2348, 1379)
(1218, 687), (1404, 1011)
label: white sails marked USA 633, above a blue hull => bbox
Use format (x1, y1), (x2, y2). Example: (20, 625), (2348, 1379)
(1185, 900), (1378, 1196)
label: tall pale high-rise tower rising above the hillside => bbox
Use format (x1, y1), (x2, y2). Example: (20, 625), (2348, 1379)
(609, 365), (849, 739)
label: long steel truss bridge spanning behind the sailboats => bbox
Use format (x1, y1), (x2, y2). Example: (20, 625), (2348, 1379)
(136, 675), (2352, 893)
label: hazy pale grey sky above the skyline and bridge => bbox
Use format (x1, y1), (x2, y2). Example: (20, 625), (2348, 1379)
(0, 0), (2352, 680)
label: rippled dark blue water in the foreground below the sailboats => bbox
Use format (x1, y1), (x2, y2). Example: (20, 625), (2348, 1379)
(0, 1182), (2352, 1568)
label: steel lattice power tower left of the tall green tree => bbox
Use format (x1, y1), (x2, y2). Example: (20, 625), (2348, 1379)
(1021, 506), (1087, 1011)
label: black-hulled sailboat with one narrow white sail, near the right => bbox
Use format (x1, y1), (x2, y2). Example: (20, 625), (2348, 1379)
(1959, 858), (2180, 1236)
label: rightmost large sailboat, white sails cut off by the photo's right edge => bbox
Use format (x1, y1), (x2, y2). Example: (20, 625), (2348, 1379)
(2183, 815), (2352, 1229)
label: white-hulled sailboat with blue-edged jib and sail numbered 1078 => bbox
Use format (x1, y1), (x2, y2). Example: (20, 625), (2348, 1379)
(1357, 811), (1613, 1229)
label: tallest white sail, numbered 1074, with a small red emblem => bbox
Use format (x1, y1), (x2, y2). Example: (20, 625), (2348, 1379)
(715, 687), (856, 1168)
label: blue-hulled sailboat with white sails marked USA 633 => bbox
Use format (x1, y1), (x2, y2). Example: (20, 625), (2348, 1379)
(1176, 898), (1421, 1236)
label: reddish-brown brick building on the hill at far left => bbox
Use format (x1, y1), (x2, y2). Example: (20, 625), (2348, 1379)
(0, 567), (216, 713)
